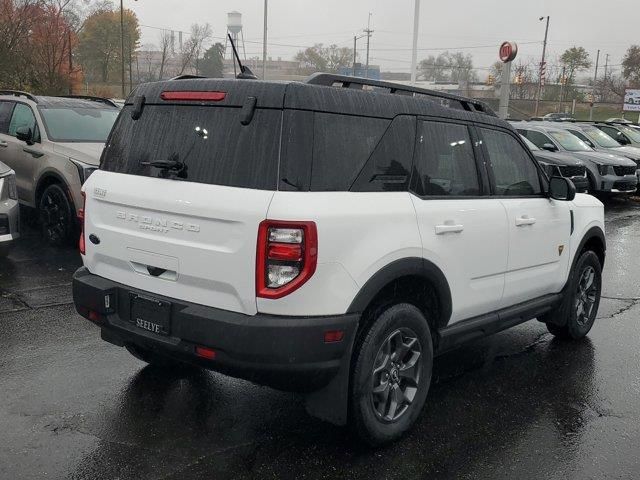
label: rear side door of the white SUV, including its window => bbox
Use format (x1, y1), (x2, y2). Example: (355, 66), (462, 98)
(411, 120), (508, 323)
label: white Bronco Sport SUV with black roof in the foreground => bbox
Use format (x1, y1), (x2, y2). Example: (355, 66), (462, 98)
(73, 74), (606, 444)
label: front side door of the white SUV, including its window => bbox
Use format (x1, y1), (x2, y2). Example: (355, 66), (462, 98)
(478, 127), (571, 307)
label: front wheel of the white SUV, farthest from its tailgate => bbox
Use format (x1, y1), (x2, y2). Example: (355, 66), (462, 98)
(543, 251), (602, 340)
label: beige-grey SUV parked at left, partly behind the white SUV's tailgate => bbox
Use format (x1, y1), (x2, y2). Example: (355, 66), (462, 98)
(0, 90), (119, 245)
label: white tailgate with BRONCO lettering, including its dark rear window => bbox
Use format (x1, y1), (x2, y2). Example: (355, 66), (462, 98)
(84, 92), (282, 314)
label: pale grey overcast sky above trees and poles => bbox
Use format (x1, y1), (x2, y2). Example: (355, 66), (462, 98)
(124, 0), (640, 77)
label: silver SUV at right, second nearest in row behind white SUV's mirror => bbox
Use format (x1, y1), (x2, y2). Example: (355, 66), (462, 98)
(513, 122), (638, 193)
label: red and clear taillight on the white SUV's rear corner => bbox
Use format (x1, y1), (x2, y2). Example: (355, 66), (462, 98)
(256, 220), (318, 298)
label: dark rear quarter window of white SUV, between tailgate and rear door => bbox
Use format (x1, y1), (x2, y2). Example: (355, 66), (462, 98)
(311, 113), (391, 191)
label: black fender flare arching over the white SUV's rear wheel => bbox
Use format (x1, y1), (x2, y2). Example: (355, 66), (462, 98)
(347, 257), (453, 328)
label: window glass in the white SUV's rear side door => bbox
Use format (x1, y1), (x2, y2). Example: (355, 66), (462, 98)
(412, 121), (480, 196)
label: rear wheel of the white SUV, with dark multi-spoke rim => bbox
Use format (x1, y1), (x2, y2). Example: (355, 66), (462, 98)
(350, 304), (433, 446)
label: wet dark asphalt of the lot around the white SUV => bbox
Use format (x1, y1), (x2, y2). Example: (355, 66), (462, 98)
(0, 201), (640, 480)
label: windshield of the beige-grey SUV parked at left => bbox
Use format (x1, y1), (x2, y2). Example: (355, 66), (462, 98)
(39, 107), (119, 143)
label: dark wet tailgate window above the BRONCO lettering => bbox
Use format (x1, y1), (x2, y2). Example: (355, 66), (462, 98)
(101, 105), (282, 190)
